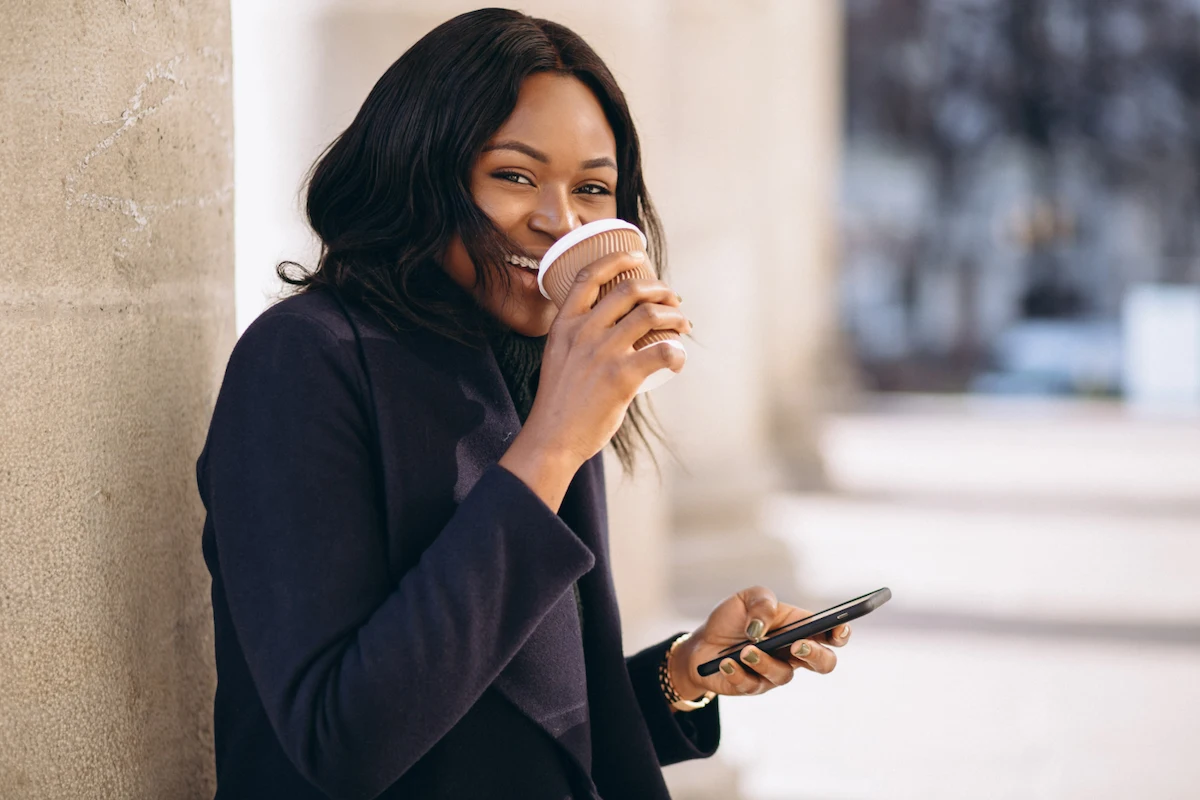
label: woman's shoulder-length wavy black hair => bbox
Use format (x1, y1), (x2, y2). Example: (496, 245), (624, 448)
(276, 8), (666, 474)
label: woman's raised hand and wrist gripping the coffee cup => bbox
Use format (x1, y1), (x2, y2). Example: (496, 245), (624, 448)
(500, 253), (691, 510)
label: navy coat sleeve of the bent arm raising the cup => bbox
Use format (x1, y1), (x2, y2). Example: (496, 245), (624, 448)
(198, 313), (594, 799)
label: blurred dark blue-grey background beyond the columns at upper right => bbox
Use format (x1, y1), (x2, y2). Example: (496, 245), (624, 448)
(841, 0), (1200, 403)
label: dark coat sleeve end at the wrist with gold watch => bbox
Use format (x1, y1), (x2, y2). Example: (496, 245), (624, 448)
(625, 633), (721, 766)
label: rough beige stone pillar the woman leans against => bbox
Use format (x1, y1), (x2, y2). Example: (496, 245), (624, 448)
(0, 0), (234, 800)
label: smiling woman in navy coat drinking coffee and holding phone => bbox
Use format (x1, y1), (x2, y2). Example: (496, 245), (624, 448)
(198, 10), (848, 800)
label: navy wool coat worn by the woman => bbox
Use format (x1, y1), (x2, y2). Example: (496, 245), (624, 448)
(197, 290), (719, 800)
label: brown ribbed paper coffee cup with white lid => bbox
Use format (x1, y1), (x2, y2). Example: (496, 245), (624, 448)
(538, 219), (686, 393)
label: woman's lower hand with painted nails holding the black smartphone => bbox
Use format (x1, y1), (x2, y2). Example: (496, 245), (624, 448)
(670, 587), (850, 700)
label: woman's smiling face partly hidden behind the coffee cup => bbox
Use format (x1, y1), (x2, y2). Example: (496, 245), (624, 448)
(443, 72), (617, 336)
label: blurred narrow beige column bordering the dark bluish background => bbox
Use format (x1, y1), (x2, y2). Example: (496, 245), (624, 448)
(756, 0), (846, 488)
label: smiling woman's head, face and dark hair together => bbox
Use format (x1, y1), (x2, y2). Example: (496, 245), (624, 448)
(286, 8), (676, 471)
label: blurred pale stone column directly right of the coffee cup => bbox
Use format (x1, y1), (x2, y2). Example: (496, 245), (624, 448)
(655, 0), (793, 614)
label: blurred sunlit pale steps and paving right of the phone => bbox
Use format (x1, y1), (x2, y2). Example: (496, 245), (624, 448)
(671, 399), (1200, 800)
